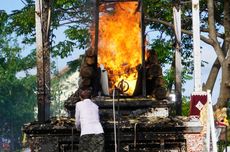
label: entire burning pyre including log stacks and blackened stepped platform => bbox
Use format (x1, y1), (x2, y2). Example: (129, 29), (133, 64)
(24, 0), (205, 152)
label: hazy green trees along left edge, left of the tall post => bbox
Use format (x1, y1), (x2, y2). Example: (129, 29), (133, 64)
(0, 9), (36, 151)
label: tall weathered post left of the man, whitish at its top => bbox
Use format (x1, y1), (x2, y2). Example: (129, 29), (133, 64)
(35, 0), (51, 122)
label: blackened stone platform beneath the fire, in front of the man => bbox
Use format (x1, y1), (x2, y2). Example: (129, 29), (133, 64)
(24, 97), (203, 152)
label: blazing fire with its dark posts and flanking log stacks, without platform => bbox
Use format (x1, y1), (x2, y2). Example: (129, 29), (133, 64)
(73, 1), (166, 99)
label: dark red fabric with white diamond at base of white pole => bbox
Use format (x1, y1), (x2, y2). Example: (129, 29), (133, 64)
(190, 93), (208, 117)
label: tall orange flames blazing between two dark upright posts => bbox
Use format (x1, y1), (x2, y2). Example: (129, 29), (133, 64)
(98, 2), (141, 95)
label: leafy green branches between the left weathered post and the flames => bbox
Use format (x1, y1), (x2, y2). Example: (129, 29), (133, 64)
(52, 0), (93, 58)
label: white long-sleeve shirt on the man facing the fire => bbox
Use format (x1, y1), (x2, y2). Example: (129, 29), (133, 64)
(75, 99), (104, 136)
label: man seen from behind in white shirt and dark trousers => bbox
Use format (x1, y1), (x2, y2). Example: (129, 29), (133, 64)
(75, 89), (104, 152)
